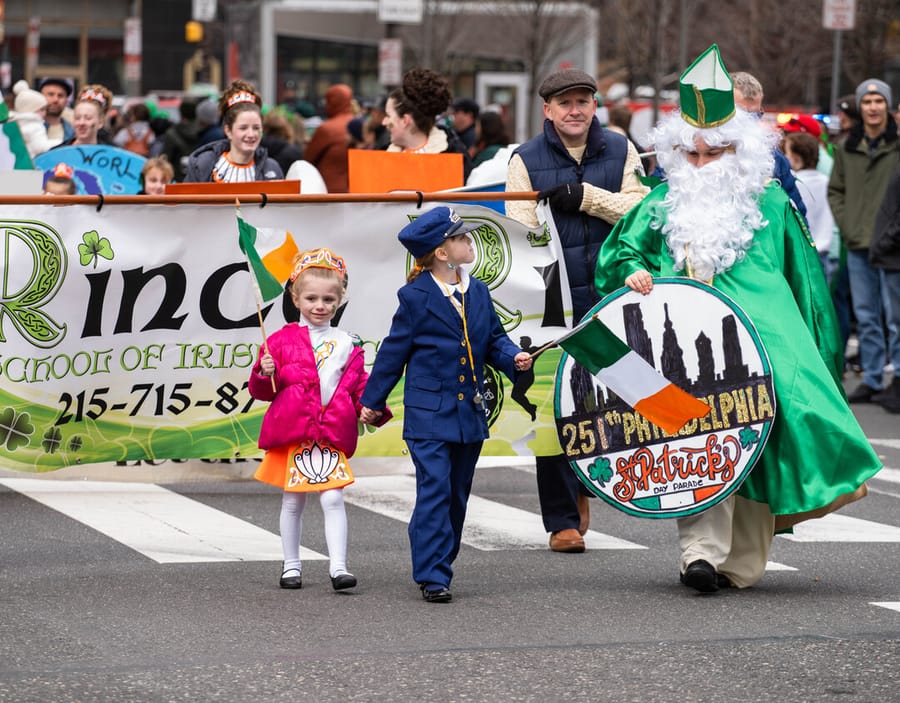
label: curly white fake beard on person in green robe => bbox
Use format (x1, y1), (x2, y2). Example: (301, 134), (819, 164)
(656, 153), (766, 281)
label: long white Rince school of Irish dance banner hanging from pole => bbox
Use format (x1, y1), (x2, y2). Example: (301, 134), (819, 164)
(0, 203), (571, 471)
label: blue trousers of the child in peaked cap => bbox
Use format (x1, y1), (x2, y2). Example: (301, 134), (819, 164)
(406, 439), (482, 588)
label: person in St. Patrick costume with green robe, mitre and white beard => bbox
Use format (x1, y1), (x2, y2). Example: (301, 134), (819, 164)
(595, 45), (881, 592)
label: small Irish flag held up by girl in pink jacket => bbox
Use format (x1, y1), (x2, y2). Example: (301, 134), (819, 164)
(237, 211), (298, 304)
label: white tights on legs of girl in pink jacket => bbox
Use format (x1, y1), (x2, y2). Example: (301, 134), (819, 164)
(279, 488), (347, 576)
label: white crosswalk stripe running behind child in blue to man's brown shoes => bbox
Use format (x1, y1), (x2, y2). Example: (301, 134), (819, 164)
(344, 475), (647, 551)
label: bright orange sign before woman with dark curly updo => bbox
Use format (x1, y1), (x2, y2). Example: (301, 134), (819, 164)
(347, 149), (465, 193)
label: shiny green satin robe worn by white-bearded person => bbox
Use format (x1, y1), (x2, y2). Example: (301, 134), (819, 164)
(595, 183), (881, 515)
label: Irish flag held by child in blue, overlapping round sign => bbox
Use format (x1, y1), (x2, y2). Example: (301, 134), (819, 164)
(557, 315), (710, 434)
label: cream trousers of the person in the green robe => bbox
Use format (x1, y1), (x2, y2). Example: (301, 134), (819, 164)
(676, 495), (775, 588)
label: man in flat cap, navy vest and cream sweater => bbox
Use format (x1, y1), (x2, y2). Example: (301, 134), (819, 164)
(506, 68), (648, 552)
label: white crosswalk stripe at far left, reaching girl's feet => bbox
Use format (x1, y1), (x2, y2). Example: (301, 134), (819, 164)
(0, 478), (327, 564)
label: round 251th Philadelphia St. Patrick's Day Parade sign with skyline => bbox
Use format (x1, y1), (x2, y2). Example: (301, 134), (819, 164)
(554, 278), (775, 518)
